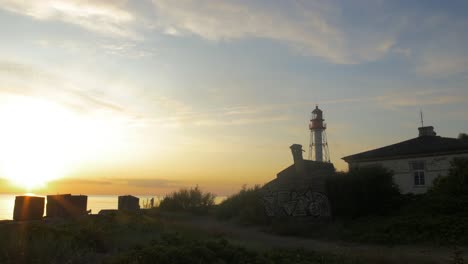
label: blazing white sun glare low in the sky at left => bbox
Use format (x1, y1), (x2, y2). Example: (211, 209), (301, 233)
(0, 96), (130, 191)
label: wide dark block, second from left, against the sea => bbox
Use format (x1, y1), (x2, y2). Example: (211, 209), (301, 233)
(46, 194), (88, 218)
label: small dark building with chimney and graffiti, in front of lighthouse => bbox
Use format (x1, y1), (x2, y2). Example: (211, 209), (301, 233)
(262, 144), (335, 219)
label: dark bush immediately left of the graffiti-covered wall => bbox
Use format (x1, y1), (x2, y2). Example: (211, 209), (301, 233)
(216, 185), (270, 224)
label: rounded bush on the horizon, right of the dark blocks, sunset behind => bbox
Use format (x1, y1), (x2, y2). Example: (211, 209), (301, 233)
(159, 186), (216, 213)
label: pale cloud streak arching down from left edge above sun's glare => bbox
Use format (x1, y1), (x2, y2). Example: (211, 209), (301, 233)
(0, 60), (142, 123)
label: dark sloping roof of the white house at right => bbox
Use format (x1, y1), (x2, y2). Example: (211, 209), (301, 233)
(343, 136), (468, 163)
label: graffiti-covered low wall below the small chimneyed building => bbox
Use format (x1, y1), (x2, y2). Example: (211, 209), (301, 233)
(263, 190), (331, 217)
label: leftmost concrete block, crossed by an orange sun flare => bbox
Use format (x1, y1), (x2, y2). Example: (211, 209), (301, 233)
(13, 196), (45, 221)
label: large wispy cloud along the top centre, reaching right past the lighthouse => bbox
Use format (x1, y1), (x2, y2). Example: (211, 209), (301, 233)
(153, 0), (396, 64)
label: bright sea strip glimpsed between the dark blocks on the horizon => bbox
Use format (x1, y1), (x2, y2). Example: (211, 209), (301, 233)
(0, 194), (226, 220)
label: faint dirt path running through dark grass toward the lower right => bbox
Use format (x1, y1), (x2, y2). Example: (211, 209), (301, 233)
(167, 216), (468, 264)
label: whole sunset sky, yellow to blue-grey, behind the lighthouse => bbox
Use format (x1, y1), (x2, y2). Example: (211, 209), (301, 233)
(0, 0), (468, 195)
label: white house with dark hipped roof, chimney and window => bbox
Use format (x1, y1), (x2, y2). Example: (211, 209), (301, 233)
(343, 126), (468, 194)
